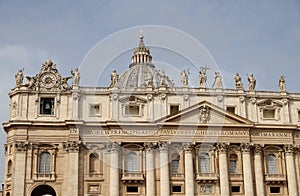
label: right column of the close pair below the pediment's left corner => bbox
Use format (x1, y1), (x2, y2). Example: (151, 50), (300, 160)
(159, 142), (170, 196)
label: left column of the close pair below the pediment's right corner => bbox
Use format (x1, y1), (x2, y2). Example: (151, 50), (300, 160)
(241, 144), (254, 196)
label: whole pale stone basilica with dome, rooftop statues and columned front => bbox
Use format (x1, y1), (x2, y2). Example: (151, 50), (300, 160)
(3, 36), (300, 196)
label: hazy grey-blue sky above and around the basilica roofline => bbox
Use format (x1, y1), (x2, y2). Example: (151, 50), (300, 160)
(0, 0), (300, 181)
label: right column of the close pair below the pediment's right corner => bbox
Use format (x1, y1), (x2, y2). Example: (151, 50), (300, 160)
(254, 144), (265, 195)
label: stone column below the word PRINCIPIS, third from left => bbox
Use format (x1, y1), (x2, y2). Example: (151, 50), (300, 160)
(109, 143), (120, 196)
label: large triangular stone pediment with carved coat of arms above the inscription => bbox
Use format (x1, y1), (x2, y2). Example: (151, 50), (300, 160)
(158, 101), (253, 126)
